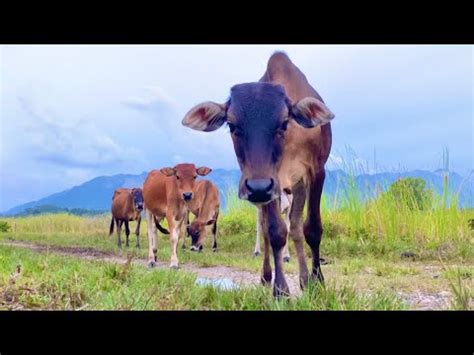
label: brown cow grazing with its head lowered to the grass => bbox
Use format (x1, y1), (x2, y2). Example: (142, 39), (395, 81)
(183, 180), (219, 251)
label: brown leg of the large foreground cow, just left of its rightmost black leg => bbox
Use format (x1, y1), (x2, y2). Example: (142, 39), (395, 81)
(289, 182), (309, 288)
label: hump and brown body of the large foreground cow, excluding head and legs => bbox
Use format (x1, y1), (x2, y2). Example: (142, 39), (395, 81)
(260, 52), (332, 188)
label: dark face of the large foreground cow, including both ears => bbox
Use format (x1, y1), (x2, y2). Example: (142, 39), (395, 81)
(182, 82), (334, 204)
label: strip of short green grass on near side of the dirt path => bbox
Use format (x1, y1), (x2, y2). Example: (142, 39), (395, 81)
(0, 246), (406, 310)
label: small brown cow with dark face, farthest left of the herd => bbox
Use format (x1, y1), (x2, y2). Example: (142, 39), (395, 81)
(109, 188), (143, 248)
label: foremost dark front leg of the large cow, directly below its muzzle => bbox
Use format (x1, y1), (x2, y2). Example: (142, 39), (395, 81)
(262, 199), (290, 298)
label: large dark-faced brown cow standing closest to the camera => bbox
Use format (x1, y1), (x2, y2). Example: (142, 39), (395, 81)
(182, 52), (334, 296)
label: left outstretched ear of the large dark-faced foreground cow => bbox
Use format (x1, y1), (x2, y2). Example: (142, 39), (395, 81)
(181, 101), (227, 132)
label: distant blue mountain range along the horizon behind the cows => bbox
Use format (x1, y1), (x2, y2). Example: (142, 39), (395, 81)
(2, 169), (474, 216)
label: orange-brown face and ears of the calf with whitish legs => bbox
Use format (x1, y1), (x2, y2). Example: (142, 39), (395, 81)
(160, 164), (212, 202)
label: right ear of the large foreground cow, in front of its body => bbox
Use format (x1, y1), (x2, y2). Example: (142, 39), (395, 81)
(291, 97), (334, 128)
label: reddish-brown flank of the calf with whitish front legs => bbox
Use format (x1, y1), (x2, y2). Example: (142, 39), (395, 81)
(143, 170), (171, 217)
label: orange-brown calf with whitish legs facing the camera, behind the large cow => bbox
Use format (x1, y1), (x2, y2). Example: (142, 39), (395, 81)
(143, 164), (211, 268)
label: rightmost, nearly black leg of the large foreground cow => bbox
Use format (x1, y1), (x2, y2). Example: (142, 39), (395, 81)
(304, 170), (325, 283)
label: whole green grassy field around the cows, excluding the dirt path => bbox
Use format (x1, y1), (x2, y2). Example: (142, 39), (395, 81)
(0, 179), (474, 309)
